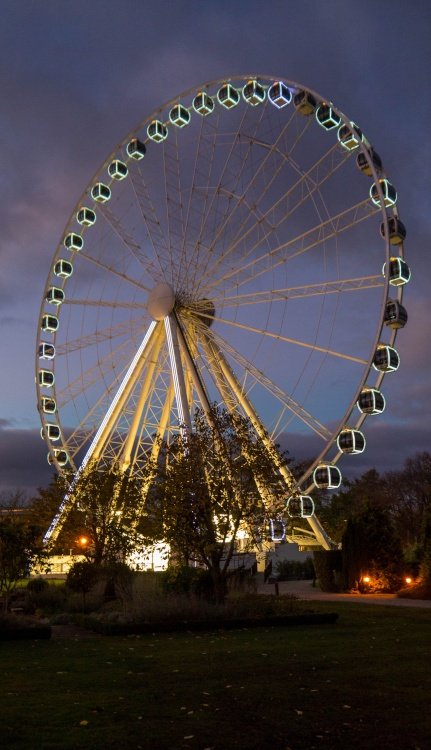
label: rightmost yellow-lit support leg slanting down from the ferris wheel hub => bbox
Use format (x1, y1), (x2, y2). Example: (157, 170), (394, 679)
(202, 334), (334, 549)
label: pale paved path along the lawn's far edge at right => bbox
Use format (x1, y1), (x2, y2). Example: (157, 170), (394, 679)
(258, 581), (431, 609)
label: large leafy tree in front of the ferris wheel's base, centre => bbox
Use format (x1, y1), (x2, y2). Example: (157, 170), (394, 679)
(156, 407), (286, 602)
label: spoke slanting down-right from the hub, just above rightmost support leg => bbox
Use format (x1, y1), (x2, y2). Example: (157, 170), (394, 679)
(202, 328), (331, 441)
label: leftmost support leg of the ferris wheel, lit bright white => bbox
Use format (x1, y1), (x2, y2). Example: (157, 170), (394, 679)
(43, 321), (161, 545)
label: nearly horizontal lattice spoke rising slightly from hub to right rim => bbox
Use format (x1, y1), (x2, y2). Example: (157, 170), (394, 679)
(208, 274), (385, 309)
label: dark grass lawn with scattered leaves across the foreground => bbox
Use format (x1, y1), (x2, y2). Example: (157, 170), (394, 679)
(0, 602), (431, 750)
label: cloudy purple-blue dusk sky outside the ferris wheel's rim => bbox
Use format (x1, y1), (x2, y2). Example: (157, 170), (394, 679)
(0, 0), (431, 500)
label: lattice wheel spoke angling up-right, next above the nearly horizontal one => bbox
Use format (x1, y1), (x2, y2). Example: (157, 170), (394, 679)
(211, 200), (379, 291)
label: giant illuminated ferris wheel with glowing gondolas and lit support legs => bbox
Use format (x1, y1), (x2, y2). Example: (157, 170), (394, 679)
(36, 76), (410, 548)
